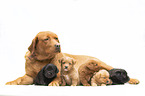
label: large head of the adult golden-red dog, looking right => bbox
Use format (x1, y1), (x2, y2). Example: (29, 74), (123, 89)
(28, 31), (61, 60)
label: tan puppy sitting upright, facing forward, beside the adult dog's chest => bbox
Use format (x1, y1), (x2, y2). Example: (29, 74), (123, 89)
(59, 57), (79, 86)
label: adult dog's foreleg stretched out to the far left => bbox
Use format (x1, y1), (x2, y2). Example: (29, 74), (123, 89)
(6, 74), (33, 85)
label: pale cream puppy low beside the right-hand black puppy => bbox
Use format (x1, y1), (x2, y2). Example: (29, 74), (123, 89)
(91, 70), (112, 86)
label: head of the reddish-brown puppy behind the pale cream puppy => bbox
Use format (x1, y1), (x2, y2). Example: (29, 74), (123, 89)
(86, 59), (101, 71)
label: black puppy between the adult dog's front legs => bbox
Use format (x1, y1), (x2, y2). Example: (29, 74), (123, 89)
(34, 64), (59, 86)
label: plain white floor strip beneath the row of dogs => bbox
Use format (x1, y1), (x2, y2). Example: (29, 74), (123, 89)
(0, 84), (145, 96)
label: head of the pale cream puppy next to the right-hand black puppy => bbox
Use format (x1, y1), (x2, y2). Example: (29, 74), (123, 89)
(96, 70), (112, 84)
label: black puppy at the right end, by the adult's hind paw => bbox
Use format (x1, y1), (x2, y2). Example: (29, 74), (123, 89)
(109, 68), (130, 85)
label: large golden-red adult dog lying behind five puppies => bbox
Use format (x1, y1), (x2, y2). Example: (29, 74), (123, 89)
(6, 31), (138, 86)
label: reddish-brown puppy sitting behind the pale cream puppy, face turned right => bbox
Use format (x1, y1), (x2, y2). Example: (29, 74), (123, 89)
(78, 59), (102, 86)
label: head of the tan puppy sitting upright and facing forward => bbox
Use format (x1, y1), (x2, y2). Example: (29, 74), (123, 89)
(59, 57), (76, 71)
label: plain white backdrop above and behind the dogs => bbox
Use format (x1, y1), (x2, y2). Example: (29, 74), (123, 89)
(0, 0), (145, 95)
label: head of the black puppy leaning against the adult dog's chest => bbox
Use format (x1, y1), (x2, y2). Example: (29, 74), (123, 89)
(43, 64), (59, 78)
